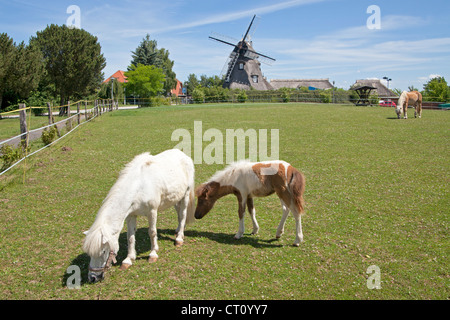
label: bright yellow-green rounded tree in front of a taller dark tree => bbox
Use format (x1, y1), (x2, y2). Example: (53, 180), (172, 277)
(125, 63), (164, 98)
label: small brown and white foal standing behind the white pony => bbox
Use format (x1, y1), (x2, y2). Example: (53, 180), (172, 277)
(195, 160), (305, 246)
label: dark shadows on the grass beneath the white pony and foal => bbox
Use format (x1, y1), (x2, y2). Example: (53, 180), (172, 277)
(61, 228), (282, 287)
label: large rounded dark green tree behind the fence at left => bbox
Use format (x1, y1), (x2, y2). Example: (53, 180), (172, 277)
(30, 24), (106, 114)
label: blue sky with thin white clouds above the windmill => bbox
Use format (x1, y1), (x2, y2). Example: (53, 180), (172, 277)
(0, 0), (450, 90)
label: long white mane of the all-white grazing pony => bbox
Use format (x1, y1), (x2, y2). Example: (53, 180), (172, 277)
(83, 152), (152, 256)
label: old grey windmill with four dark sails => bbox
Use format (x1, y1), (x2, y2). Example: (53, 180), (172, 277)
(209, 15), (275, 90)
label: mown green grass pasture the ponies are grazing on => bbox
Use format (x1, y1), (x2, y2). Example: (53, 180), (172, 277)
(0, 104), (450, 299)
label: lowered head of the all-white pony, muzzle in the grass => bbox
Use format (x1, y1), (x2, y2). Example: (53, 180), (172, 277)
(83, 226), (119, 282)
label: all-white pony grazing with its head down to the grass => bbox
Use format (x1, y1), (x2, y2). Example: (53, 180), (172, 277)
(83, 149), (195, 282)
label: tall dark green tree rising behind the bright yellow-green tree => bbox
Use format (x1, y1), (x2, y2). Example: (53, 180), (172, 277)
(128, 34), (177, 94)
